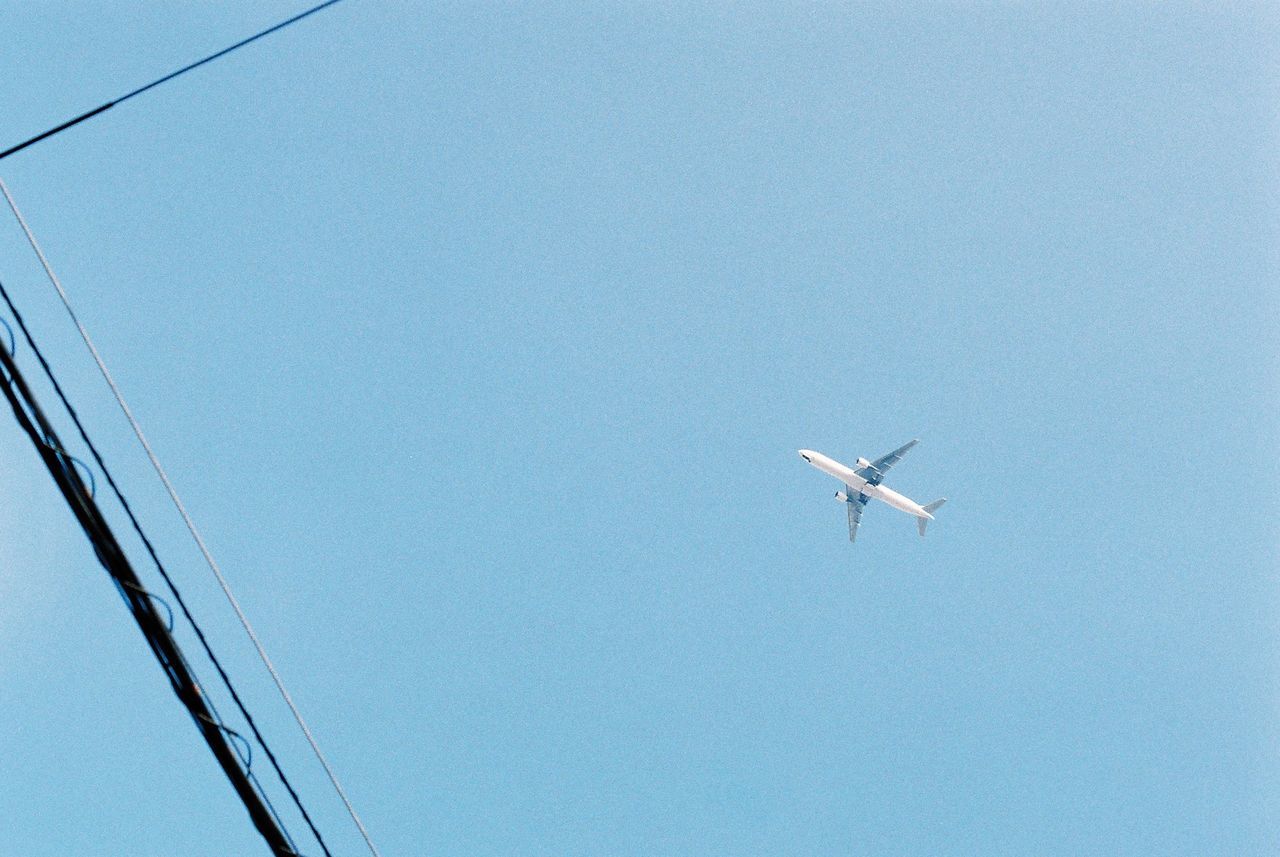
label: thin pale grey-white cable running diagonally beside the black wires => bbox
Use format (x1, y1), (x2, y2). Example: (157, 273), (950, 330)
(0, 179), (381, 857)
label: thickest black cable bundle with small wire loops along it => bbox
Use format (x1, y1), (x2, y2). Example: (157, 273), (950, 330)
(0, 299), (298, 857)
